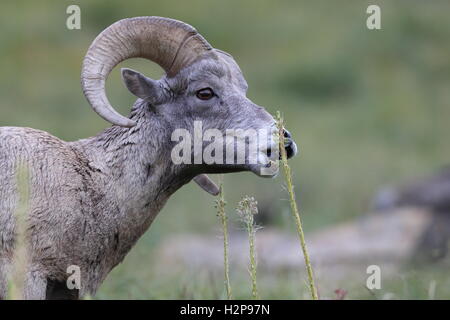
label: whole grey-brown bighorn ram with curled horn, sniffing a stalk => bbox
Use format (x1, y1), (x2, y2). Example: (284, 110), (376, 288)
(0, 17), (297, 299)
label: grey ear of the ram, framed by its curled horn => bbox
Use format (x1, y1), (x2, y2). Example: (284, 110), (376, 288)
(121, 68), (162, 103)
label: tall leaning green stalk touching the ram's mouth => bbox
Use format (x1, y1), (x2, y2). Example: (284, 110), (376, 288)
(277, 111), (319, 300)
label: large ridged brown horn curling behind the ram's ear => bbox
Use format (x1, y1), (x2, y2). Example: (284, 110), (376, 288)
(81, 17), (212, 127)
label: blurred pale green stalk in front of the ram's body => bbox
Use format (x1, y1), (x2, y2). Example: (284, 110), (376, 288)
(8, 164), (30, 300)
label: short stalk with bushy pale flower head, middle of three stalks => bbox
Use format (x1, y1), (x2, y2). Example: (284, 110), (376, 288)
(236, 196), (259, 299)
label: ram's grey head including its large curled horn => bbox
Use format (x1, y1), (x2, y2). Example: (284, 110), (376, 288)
(82, 17), (297, 193)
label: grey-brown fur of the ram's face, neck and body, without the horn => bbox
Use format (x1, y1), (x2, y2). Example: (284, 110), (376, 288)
(0, 51), (295, 299)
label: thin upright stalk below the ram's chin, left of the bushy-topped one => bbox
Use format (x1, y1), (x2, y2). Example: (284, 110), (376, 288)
(215, 175), (233, 300)
